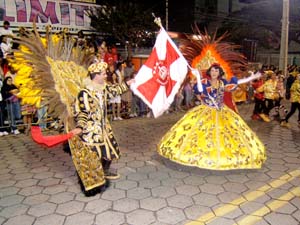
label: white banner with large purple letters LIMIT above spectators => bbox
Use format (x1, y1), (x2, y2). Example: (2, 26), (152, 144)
(0, 0), (96, 33)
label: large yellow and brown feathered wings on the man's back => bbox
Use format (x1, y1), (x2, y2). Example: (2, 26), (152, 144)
(12, 23), (92, 128)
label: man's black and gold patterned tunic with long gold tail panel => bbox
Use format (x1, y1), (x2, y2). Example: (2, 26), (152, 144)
(69, 80), (128, 190)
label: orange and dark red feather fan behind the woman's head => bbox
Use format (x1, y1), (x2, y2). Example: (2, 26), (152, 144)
(179, 25), (247, 79)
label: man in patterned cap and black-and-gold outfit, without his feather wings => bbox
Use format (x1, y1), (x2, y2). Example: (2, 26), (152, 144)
(69, 62), (132, 195)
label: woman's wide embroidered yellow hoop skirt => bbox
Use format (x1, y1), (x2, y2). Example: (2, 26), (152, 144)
(158, 105), (266, 170)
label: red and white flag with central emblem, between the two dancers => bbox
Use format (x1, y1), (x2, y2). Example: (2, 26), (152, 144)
(131, 28), (188, 117)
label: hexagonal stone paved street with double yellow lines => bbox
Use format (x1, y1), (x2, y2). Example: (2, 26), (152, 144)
(0, 104), (300, 225)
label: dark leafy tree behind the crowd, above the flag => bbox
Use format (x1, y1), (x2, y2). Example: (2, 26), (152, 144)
(88, 0), (164, 58)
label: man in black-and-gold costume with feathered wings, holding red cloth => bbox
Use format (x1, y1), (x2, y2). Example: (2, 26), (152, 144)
(10, 24), (132, 196)
